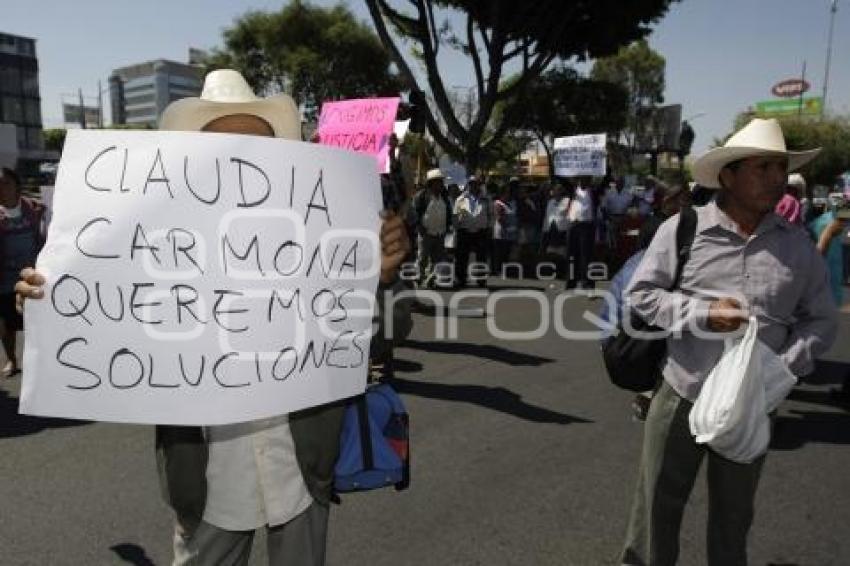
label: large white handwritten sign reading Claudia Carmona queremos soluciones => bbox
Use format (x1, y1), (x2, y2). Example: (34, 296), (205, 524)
(21, 131), (381, 425)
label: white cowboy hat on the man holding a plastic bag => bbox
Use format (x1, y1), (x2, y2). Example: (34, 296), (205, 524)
(693, 118), (820, 189)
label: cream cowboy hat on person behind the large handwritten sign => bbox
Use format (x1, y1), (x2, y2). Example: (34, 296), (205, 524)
(159, 69), (301, 140)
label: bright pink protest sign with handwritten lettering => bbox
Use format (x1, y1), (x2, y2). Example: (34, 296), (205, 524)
(318, 97), (399, 172)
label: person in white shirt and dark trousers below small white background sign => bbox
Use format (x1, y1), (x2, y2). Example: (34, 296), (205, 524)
(566, 181), (596, 289)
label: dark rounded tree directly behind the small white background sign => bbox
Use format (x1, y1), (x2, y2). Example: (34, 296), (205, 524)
(497, 65), (628, 175)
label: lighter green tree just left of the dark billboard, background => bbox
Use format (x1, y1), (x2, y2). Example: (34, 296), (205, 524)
(590, 39), (666, 170)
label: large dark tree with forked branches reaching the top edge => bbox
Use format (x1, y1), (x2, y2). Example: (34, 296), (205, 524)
(365, 0), (677, 170)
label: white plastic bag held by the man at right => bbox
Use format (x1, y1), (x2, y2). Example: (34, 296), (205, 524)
(688, 317), (797, 463)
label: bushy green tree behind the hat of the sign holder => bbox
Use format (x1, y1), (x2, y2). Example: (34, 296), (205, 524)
(208, 0), (401, 119)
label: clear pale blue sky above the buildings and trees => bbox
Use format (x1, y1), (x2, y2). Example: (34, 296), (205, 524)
(0, 0), (850, 152)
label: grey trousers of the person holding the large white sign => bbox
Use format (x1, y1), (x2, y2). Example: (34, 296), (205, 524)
(173, 502), (329, 566)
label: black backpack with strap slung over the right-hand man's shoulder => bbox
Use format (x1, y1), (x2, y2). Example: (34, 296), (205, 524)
(602, 206), (697, 391)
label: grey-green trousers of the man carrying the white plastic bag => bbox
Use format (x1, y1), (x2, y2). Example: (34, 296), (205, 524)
(621, 382), (764, 566)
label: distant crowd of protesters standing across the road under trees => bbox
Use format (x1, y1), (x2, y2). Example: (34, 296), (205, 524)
(406, 169), (690, 289)
